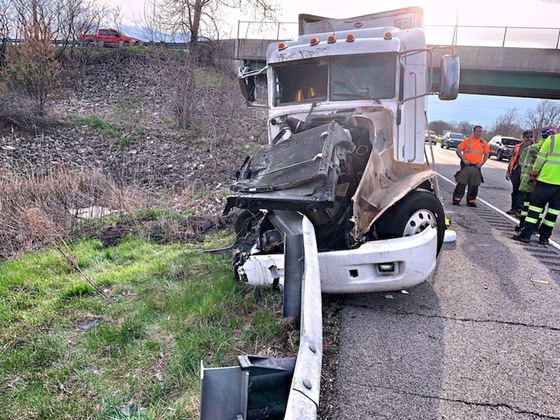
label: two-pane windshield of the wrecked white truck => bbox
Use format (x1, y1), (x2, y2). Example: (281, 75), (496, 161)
(274, 54), (397, 106)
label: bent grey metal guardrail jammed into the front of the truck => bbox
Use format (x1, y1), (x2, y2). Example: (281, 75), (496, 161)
(200, 215), (323, 420)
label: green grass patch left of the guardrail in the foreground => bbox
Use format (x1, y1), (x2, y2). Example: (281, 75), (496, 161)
(0, 225), (285, 419)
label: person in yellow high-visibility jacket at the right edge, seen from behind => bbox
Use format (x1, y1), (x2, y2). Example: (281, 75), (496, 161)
(513, 130), (560, 245)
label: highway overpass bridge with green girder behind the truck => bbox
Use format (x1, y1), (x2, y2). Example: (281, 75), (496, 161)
(230, 39), (560, 99)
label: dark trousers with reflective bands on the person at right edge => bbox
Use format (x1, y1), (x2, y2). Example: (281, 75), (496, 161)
(520, 181), (560, 239)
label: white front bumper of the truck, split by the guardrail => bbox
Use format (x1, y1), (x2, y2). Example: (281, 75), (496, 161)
(238, 228), (437, 293)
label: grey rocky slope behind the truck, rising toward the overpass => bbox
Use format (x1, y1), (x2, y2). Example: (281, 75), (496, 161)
(0, 50), (266, 217)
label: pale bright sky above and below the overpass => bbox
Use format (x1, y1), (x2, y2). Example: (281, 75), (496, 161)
(97, 0), (560, 129)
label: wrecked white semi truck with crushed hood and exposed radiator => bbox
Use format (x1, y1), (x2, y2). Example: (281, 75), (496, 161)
(226, 8), (459, 293)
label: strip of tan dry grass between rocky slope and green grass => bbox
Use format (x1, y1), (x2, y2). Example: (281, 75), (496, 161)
(0, 164), (234, 265)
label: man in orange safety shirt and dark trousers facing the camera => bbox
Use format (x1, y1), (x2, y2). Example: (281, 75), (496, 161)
(453, 125), (490, 207)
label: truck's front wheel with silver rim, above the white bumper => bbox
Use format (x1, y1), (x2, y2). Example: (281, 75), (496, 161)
(375, 189), (445, 254)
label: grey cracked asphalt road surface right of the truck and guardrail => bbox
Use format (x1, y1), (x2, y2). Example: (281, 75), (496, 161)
(331, 147), (560, 420)
